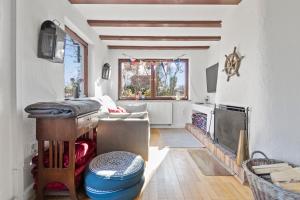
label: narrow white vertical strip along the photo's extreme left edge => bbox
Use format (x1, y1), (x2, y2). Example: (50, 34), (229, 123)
(0, 0), (16, 200)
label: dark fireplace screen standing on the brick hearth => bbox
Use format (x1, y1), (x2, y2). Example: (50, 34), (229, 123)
(214, 105), (248, 155)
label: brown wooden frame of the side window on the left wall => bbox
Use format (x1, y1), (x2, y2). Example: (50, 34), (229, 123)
(65, 26), (89, 97)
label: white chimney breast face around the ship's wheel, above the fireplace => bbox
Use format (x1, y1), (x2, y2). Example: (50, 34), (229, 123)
(216, 0), (263, 108)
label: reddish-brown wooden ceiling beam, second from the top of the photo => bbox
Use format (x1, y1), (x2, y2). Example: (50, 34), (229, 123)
(87, 20), (222, 28)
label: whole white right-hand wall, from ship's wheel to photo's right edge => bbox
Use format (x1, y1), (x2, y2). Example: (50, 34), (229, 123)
(209, 0), (300, 164)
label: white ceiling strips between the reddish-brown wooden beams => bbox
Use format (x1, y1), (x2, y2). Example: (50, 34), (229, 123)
(74, 4), (237, 46)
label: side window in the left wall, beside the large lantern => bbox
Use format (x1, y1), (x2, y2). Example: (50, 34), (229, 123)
(64, 27), (88, 98)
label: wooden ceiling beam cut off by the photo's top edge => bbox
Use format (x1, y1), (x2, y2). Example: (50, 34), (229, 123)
(69, 0), (241, 5)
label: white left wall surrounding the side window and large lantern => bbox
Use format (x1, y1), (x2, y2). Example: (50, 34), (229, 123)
(15, 0), (107, 199)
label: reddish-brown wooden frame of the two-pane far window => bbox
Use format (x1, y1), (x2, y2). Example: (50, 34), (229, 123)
(118, 58), (189, 100)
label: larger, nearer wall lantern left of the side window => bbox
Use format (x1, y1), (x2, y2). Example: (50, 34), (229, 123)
(38, 20), (66, 63)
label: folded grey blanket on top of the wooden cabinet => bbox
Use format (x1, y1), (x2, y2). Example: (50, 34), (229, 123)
(25, 99), (100, 118)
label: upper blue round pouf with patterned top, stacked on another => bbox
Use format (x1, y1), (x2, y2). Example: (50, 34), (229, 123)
(84, 151), (145, 194)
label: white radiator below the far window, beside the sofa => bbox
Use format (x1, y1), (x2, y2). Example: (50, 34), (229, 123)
(147, 102), (173, 125)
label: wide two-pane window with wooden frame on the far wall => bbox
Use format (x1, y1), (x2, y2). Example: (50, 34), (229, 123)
(119, 59), (188, 100)
